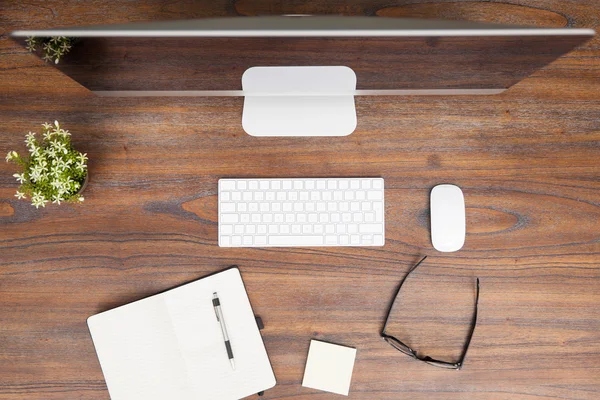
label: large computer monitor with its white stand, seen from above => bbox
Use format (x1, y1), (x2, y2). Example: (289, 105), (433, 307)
(12, 16), (595, 136)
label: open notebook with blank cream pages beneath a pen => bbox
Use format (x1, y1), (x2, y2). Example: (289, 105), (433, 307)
(88, 268), (275, 400)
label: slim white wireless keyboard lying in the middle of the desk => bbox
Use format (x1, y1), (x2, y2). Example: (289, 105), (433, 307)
(219, 178), (385, 247)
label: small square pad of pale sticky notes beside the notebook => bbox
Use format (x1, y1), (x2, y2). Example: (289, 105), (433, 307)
(302, 340), (356, 396)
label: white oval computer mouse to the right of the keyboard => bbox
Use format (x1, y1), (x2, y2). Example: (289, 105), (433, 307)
(429, 185), (466, 252)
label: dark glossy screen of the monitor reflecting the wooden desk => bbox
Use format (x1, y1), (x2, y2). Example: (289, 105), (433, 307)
(14, 32), (589, 91)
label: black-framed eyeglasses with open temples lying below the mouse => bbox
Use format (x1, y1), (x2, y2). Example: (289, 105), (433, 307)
(381, 256), (479, 370)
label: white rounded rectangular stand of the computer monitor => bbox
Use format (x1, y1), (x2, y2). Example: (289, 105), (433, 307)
(242, 67), (356, 136)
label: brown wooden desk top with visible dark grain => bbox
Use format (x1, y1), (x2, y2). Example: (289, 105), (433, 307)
(0, 0), (600, 400)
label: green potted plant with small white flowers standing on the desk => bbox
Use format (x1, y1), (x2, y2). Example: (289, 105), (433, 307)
(6, 121), (88, 208)
